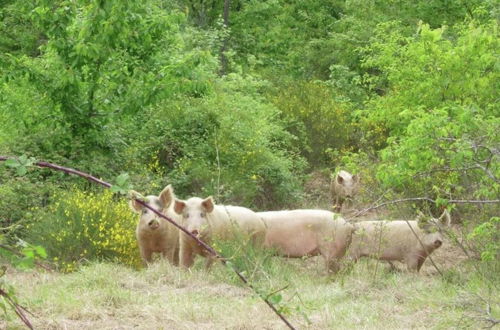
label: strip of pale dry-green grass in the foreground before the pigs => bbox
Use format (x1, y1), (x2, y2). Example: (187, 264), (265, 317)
(0, 238), (499, 329)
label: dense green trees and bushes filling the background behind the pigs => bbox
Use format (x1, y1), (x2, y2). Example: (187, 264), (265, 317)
(0, 0), (500, 328)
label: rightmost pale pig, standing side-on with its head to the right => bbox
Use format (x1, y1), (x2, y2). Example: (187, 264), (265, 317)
(349, 210), (451, 272)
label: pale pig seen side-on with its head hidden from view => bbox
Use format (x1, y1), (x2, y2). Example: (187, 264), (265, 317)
(257, 210), (354, 272)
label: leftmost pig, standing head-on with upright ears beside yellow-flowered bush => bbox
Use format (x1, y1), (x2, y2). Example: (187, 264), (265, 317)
(129, 185), (180, 266)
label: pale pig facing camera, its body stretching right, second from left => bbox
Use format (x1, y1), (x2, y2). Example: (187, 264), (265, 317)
(174, 196), (265, 269)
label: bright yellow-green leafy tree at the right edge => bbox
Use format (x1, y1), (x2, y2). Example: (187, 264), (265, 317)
(361, 22), (500, 204)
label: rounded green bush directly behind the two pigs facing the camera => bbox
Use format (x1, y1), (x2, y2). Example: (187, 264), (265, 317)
(125, 75), (304, 207)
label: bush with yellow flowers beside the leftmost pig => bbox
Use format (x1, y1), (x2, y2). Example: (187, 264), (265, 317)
(27, 190), (140, 272)
